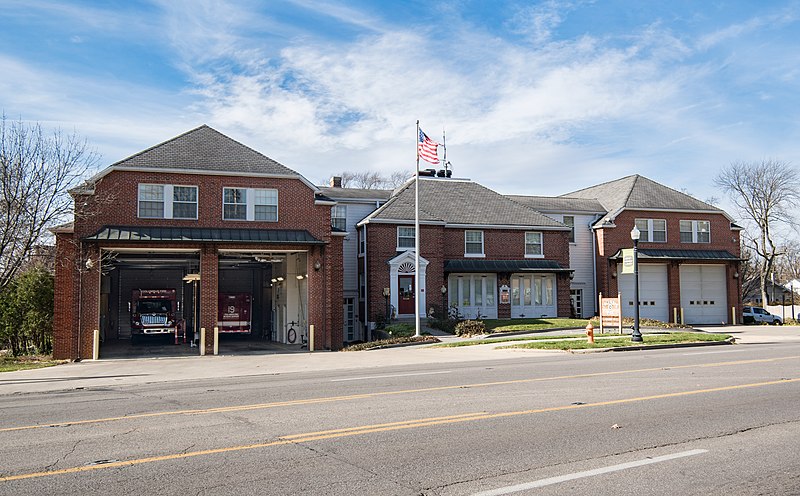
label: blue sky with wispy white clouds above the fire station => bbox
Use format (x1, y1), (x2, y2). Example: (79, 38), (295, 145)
(0, 0), (800, 208)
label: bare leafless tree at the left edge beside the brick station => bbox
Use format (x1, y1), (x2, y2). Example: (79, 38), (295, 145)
(0, 116), (97, 289)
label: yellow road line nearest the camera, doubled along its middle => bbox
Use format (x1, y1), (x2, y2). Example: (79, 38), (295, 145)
(0, 378), (800, 482)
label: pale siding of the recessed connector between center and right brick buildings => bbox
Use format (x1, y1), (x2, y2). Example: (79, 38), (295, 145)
(545, 212), (597, 318)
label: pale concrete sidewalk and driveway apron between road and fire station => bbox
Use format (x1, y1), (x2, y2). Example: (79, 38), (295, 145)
(0, 326), (800, 395)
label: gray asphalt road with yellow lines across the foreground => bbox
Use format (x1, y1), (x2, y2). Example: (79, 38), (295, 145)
(0, 342), (800, 495)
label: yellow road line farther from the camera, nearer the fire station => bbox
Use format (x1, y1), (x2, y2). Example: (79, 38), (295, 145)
(0, 355), (800, 433)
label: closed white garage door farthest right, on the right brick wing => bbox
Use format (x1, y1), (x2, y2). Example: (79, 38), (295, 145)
(680, 265), (728, 324)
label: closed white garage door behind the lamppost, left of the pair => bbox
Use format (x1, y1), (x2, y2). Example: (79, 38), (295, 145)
(617, 263), (669, 322)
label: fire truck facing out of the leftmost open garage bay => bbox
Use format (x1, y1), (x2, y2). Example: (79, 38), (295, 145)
(128, 289), (178, 339)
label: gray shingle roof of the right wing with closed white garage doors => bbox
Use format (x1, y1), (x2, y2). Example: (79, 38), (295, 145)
(561, 174), (722, 214)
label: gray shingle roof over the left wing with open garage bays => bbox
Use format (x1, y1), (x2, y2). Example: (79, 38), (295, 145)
(111, 124), (300, 177)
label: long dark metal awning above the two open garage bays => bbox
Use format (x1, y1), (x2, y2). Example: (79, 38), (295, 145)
(84, 226), (324, 245)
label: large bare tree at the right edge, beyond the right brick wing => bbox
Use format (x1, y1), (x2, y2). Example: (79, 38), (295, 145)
(715, 159), (800, 302)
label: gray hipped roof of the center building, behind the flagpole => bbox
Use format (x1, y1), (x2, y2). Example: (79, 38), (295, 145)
(361, 177), (568, 229)
